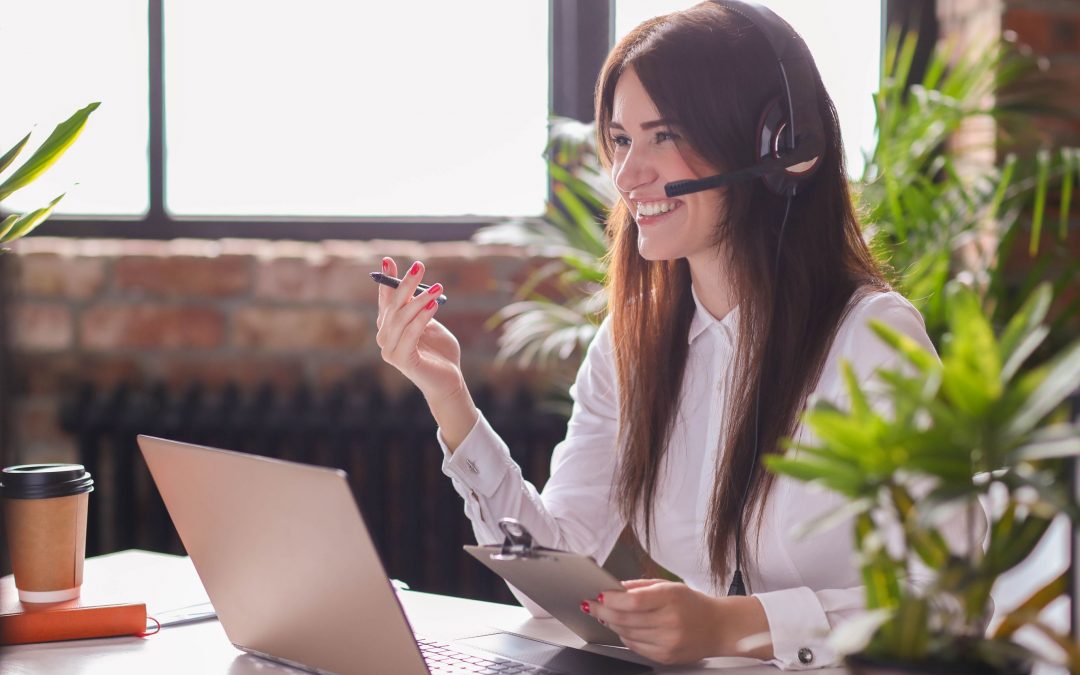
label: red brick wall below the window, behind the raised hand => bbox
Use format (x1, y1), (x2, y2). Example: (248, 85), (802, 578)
(5, 238), (539, 462)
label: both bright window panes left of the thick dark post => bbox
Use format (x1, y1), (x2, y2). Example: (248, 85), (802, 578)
(0, 0), (549, 228)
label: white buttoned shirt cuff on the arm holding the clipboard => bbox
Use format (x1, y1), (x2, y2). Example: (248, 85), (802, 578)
(754, 586), (837, 671)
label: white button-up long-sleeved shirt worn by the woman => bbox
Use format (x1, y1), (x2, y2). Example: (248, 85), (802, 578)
(440, 292), (933, 670)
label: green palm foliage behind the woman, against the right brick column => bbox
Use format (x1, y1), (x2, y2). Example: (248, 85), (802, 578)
(854, 31), (1080, 347)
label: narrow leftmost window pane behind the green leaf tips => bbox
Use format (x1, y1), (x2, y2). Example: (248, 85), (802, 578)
(0, 0), (149, 216)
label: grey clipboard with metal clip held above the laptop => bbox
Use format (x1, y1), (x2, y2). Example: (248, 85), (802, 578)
(464, 518), (624, 647)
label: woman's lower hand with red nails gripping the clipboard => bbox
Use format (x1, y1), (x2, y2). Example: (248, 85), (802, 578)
(582, 579), (772, 663)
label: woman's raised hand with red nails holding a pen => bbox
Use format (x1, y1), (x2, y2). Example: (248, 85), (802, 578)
(375, 258), (478, 451)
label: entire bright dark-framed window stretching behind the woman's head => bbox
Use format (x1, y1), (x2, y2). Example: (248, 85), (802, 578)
(0, 0), (894, 240)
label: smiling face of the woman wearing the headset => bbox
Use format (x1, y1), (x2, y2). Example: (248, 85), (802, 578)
(609, 68), (720, 262)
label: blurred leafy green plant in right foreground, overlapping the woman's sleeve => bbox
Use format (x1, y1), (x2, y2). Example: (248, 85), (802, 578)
(766, 282), (1080, 675)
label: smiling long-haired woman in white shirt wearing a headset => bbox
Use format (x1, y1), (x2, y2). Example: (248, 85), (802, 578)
(377, 2), (954, 669)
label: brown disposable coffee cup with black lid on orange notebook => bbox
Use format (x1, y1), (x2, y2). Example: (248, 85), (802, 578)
(0, 464), (94, 603)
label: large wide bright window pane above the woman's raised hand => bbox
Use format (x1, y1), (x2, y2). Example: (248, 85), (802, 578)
(164, 0), (548, 216)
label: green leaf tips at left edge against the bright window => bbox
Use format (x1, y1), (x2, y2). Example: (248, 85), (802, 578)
(0, 103), (102, 251)
